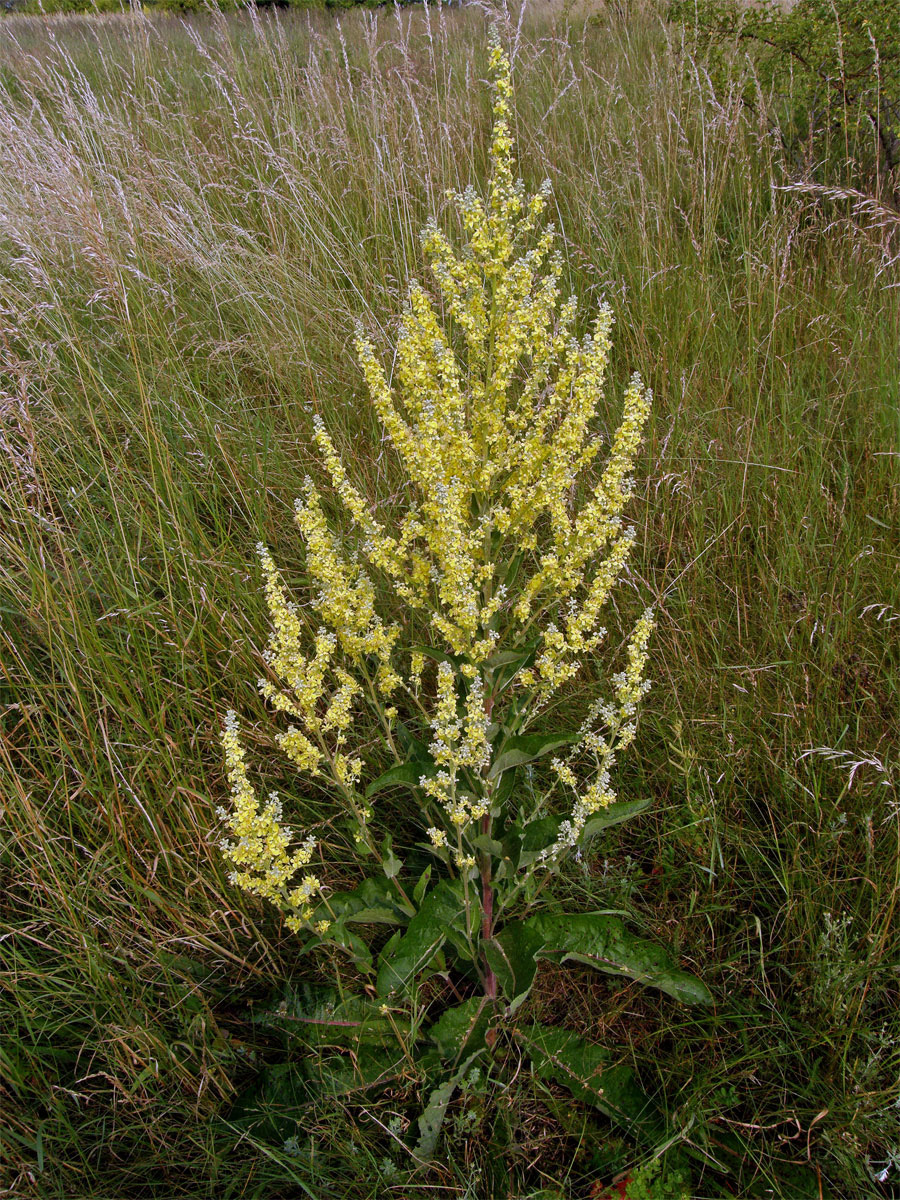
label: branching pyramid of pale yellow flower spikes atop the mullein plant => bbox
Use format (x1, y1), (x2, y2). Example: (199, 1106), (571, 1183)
(222, 37), (653, 955)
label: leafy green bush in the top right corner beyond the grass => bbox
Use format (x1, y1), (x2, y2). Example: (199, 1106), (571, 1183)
(668, 0), (900, 200)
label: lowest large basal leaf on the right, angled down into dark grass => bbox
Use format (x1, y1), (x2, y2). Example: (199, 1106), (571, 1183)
(516, 1025), (665, 1141)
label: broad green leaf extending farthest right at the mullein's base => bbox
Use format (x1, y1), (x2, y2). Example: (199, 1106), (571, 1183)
(525, 912), (713, 1004)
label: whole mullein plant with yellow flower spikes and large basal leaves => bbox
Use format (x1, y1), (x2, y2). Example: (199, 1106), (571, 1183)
(220, 34), (709, 1156)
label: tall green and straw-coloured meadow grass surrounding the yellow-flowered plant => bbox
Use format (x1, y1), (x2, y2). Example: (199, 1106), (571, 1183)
(0, 5), (900, 1200)
